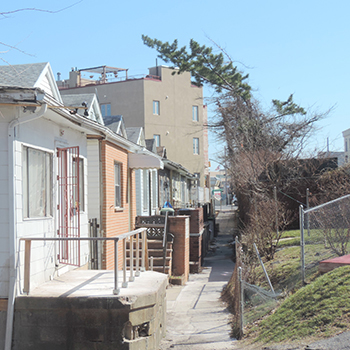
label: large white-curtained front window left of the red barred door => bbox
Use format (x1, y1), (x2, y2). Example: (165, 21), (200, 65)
(23, 147), (52, 218)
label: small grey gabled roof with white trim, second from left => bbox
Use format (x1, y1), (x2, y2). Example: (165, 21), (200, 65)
(62, 94), (104, 125)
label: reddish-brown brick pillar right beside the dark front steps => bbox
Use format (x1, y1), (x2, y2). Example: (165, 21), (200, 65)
(168, 215), (190, 282)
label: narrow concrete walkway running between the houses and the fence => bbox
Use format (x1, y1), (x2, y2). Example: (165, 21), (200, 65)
(161, 206), (235, 350)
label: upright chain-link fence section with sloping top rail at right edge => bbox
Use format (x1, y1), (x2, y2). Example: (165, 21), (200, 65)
(300, 195), (350, 284)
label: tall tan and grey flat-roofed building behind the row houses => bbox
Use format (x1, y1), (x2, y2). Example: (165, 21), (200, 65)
(57, 66), (209, 187)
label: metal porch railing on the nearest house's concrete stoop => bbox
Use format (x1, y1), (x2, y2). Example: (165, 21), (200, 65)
(20, 228), (148, 295)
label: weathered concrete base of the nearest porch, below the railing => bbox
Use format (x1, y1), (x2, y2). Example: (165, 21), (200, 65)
(12, 272), (167, 350)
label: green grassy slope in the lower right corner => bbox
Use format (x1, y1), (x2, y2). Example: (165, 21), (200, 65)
(257, 266), (350, 342)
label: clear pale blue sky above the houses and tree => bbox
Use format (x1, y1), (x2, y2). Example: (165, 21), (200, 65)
(0, 0), (350, 169)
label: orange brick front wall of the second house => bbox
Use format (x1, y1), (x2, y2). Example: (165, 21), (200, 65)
(101, 141), (136, 269)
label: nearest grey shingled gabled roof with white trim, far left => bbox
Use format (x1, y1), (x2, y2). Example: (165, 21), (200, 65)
(0, 62), (62, 102)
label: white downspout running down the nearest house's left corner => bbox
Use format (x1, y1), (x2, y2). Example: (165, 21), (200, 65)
(5, 103), (47, 350)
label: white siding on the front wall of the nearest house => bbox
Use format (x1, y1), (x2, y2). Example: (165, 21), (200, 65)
(0, 108), (89, 298)
